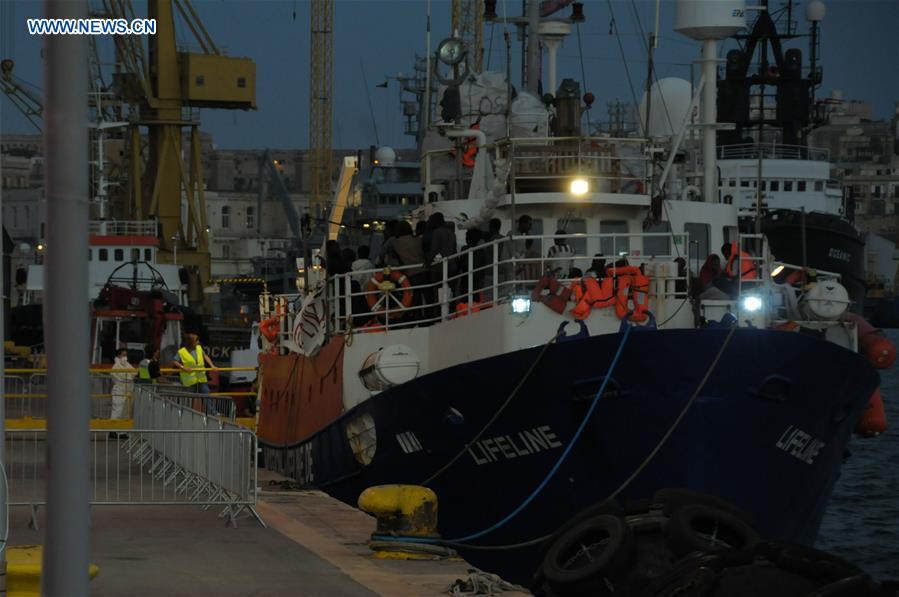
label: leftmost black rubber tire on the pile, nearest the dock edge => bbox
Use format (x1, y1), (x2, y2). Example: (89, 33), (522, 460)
(541, 514), (634, 594)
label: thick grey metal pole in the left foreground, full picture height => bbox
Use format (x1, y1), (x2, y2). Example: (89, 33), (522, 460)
(41, 0), (90, 596)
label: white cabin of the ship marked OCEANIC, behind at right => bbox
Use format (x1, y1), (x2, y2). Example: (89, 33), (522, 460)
(718, 143), (844, 216)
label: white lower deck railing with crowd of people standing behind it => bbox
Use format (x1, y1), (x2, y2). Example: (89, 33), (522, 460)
(326, 233), (690, 333)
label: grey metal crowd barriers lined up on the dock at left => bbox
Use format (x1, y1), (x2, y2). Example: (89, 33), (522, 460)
(5, 386), (264, 526)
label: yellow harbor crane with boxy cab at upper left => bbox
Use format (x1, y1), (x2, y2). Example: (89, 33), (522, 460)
(104, 0), (256, 304)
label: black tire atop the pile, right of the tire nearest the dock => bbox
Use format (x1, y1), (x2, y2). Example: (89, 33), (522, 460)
(665, 504), (761, 563)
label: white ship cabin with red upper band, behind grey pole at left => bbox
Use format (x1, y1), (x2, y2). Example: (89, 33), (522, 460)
(26, 220), (187, 304)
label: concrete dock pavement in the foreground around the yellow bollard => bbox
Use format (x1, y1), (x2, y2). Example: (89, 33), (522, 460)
(9, 482), (523, 596)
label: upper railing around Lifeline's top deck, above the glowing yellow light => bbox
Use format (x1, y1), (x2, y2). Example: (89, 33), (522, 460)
(422, 137), (652, 198)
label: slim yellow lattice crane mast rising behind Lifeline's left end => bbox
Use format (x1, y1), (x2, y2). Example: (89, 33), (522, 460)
(309, 0), (334, 218)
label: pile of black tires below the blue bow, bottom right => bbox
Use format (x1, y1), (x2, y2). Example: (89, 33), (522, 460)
(532, 489), (897, 597)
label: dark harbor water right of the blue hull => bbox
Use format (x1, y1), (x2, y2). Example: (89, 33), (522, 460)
(817, 330), (899, 581)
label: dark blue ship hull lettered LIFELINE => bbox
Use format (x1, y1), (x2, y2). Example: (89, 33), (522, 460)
(263, 329), (879, 582)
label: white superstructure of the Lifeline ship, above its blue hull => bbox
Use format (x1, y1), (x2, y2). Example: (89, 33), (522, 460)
(272, 132), (762, 408)
